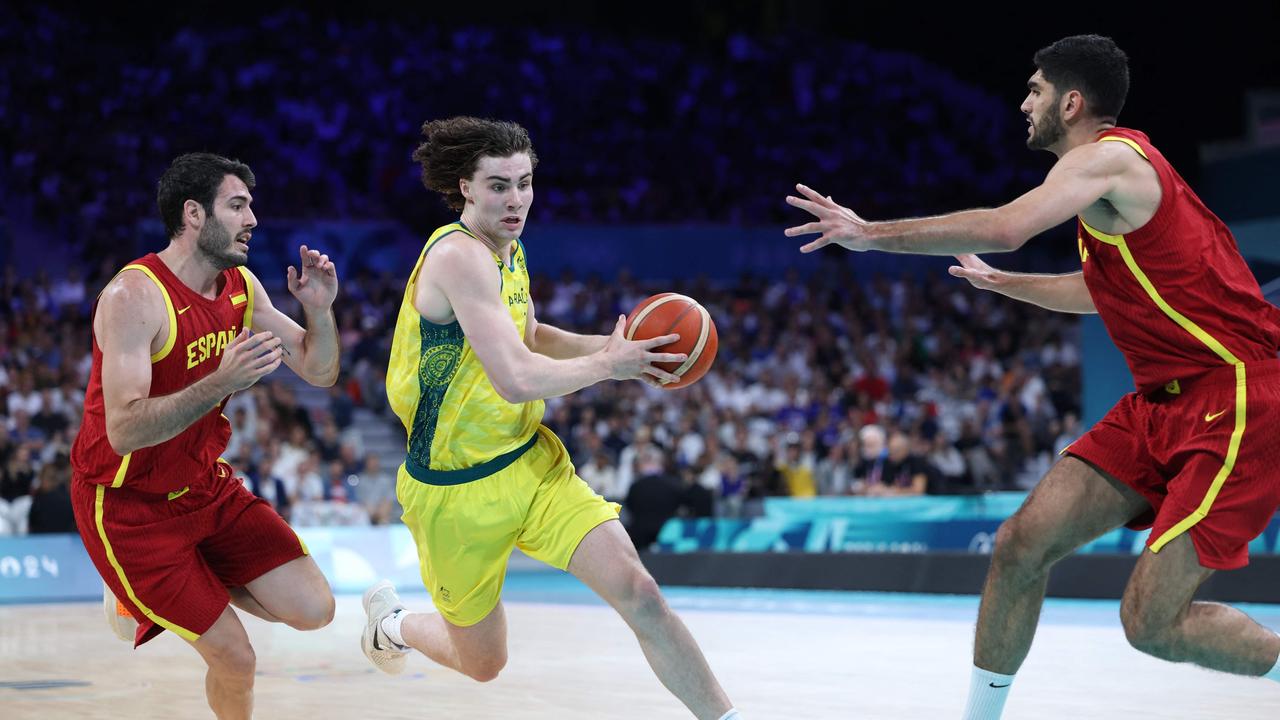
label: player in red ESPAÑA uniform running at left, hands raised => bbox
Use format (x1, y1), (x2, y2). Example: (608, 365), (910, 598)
(72, 154), (338, 719)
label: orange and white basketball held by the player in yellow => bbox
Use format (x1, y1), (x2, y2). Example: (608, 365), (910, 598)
(626, 292), (719, 389)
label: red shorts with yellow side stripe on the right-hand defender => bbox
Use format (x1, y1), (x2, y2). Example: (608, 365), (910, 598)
(1066, 360), (1280, 570)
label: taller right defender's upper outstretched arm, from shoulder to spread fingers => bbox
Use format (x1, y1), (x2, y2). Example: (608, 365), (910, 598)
(786, 142), (1137, 255)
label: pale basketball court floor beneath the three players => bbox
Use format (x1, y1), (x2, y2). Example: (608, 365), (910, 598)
(0, 571), (1280, 720)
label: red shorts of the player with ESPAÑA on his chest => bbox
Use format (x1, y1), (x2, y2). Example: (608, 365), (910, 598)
(72, 462), (307, 647)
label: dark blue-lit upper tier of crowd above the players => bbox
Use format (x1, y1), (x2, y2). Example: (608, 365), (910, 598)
(0, 4), (1039, 258)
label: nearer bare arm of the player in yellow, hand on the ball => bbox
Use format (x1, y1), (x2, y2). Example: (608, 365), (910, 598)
(430, 236), (684, 402)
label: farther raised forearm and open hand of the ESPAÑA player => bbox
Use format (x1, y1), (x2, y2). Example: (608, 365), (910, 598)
(246, 245), (342, 387)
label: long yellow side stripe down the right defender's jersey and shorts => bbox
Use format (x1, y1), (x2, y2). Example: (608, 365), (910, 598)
(1080, 219), (1248, 552)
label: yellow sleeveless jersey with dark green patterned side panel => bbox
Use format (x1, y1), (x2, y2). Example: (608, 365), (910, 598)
(387, 223), (544, 484)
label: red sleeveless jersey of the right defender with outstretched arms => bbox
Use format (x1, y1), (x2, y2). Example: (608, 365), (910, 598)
(1078, 128), (1280, 392)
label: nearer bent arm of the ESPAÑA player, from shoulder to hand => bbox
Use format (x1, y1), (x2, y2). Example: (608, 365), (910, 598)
(93, 270), (280, 456)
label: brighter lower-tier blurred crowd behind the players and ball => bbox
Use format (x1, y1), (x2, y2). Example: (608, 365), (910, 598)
(0, 264), (1080, 538)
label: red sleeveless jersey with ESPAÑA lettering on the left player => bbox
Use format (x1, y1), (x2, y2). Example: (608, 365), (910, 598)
(72, 252), (253, 493)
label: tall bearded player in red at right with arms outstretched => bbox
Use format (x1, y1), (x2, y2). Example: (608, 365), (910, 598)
(786, 36), (1280, 720)
